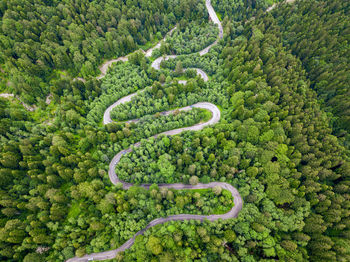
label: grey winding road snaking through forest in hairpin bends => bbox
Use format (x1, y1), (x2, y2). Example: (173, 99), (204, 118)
(67, 0), (243, 262)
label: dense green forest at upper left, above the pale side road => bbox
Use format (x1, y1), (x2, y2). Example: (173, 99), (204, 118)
(0, 0), (206, 103)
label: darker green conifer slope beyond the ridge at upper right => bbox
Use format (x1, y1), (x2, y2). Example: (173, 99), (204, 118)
(273, 1), (350, 139)
